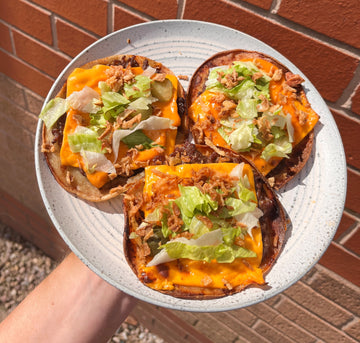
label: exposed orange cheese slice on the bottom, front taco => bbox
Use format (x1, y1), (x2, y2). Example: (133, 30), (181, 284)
(138, 163), (264, 290)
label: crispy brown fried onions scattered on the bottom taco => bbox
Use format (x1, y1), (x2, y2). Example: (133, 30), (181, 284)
(125, 167), (242, 259)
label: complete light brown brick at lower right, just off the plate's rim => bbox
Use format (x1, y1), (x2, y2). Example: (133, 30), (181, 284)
(285, 282), (353, 328)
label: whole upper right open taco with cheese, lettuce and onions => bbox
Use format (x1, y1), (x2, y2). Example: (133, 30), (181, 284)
(188, 50), (319, 189)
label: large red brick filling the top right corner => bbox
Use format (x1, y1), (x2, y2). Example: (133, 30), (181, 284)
(277, 0), (360, 48)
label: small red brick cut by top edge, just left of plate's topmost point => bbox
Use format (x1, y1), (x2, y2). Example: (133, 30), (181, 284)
(119, 0), (178, 19)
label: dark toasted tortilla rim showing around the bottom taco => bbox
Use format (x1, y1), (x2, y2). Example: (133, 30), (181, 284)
(123, 142), (286, 299)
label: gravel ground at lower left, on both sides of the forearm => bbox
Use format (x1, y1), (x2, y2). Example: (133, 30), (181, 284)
(0, 223), (164, 343)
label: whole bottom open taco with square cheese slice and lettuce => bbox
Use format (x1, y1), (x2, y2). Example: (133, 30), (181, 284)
(123, 143), (286, 299)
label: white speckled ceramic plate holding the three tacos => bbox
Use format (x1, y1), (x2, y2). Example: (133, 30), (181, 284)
(35, 20), (346, 312)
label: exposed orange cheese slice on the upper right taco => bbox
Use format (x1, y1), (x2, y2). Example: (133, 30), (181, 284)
(189, 58), (319, 175)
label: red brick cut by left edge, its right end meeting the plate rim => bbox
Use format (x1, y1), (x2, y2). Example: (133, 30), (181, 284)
(0, 51), (54, 97)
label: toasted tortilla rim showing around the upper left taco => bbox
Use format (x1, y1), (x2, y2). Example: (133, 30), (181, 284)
(42, 55), (187, 202)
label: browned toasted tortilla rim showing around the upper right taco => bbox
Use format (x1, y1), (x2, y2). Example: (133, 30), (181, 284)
(187, 49), (319, 189)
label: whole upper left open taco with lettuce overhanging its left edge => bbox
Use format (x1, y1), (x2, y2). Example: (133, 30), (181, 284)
(40, 55), (186, 202)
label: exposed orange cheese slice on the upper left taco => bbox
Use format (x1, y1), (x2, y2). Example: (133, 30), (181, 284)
(60, 65), (180, 188)
